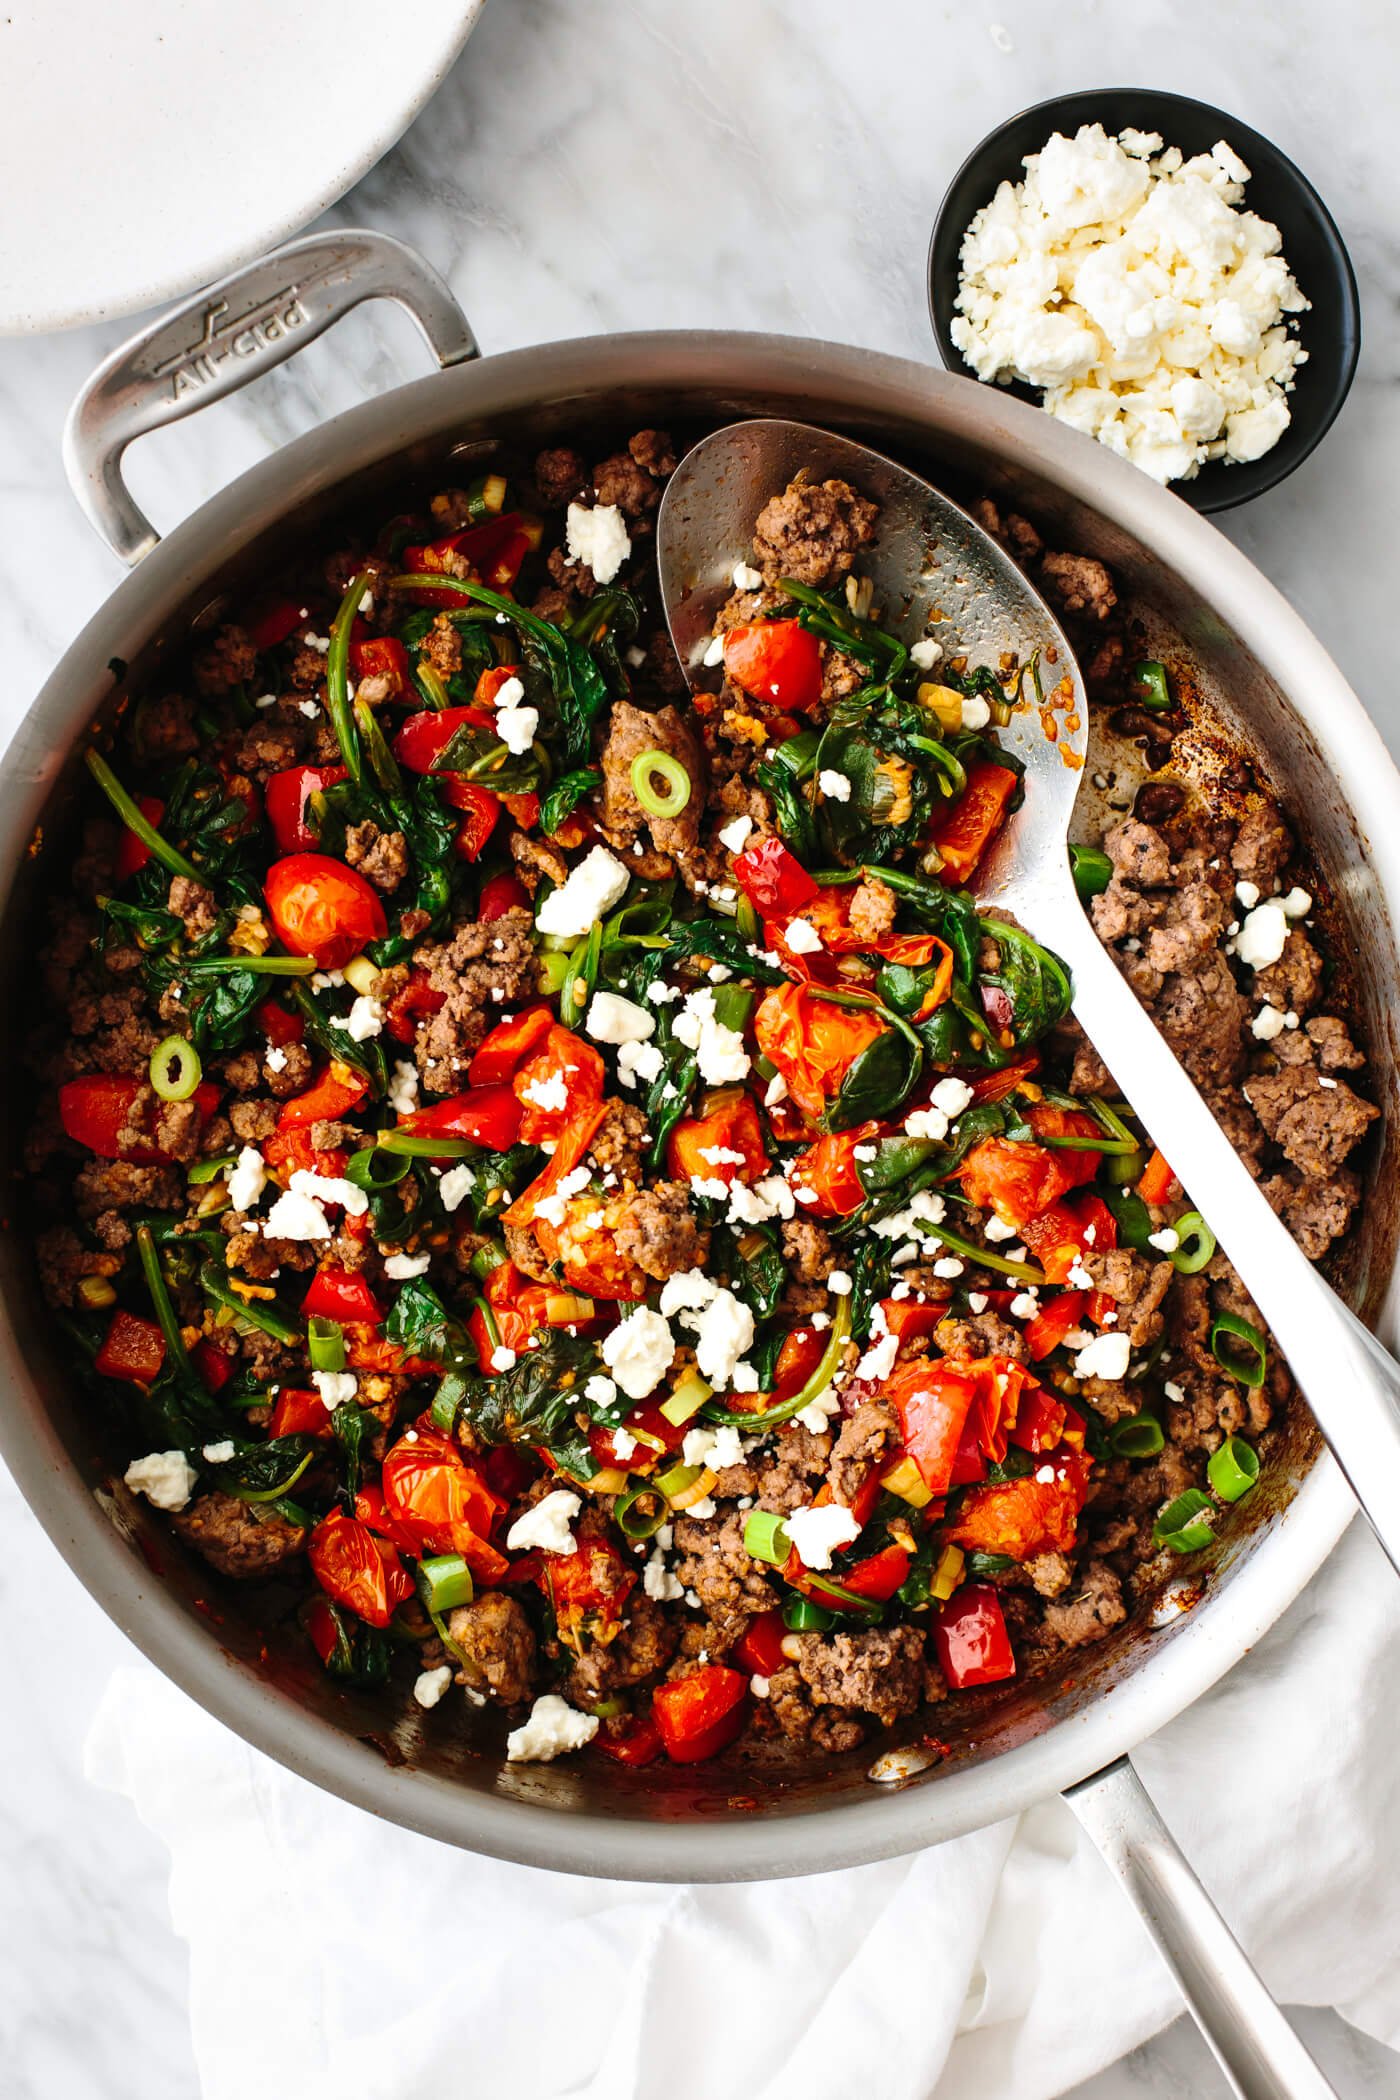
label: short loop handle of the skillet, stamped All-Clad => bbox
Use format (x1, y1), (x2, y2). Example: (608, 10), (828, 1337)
(63, 229), (481, 567)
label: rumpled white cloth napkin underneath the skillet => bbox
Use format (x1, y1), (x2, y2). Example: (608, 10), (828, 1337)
(88, 1525), (1400, 2100)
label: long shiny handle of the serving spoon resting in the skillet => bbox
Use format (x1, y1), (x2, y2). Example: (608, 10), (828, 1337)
(1041, 893), (1400, 1573)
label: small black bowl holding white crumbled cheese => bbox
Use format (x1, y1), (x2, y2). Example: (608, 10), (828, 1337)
(928, 88), (1360, 510)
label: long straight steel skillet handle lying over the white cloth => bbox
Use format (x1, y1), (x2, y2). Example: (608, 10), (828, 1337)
(1064, 1758), (1337, 2100)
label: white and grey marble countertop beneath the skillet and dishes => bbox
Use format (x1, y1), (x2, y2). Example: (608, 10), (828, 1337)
(0, 0), (1400, 2100)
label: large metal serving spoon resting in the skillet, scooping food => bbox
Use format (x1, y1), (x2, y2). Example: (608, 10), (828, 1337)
(657, 418), (1400, 1571)
